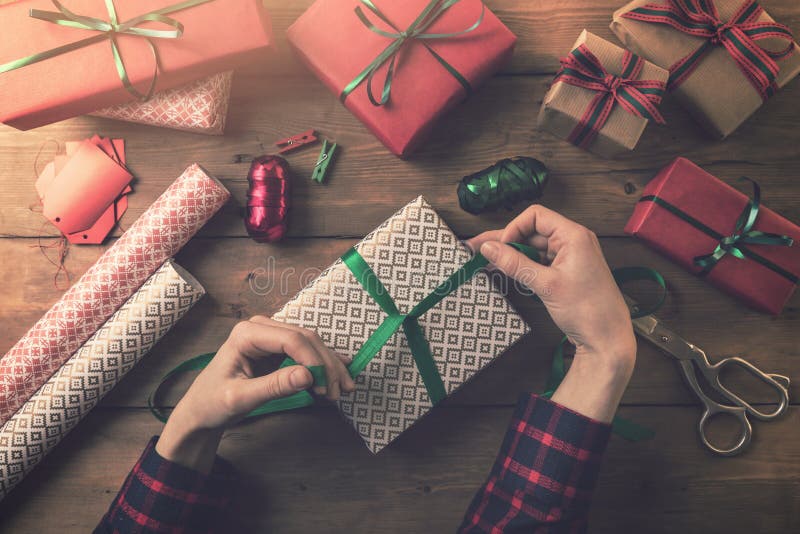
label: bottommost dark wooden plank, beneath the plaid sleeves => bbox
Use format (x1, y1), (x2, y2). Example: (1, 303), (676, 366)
(0, 407), (800, 533)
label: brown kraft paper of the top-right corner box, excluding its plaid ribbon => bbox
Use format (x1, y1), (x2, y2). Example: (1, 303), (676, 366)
(611, 0), (800, 138)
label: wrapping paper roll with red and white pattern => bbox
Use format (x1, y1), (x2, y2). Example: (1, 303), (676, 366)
(0, 164), (230, 424)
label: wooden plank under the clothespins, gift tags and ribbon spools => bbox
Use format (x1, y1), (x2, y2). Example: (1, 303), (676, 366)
(0, 72), (800, 237)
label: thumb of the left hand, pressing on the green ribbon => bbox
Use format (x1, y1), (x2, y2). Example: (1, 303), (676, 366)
(234, 365), (314, 413)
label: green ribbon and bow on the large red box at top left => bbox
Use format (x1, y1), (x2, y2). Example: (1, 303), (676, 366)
(0, 0), (213, 100)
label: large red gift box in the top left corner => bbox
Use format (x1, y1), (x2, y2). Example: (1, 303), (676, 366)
(0, 0), (271, 130)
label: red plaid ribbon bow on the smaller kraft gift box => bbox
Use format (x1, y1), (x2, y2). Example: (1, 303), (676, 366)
(553, 45), (666, 148)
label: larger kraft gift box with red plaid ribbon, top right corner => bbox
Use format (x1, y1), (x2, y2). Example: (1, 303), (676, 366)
(611, 0), (800, 138)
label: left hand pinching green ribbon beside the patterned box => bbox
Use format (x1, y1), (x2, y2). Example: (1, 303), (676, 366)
(156, 316), (355, 471)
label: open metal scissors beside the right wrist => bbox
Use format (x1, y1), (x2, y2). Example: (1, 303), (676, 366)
(625, 296), (789, 456)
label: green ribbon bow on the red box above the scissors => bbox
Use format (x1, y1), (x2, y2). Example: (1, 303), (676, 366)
(694, 177), (794, 274)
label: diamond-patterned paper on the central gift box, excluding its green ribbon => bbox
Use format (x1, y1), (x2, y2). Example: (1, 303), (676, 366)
(273, 197), (529, 452)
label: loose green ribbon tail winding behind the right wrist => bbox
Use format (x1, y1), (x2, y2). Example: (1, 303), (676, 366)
(541, 267), (667, 441)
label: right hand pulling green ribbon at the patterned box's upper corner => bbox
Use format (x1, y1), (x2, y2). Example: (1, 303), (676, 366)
(467, 205), (636, 420)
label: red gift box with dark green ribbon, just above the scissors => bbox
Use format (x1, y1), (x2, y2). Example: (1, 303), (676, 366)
(625, 158), (800, 314)
